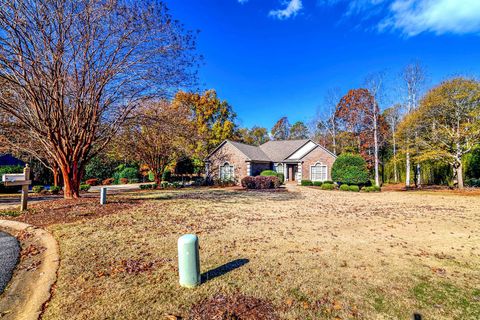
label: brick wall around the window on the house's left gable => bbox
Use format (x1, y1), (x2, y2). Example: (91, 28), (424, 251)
(209, 142), (248, 183)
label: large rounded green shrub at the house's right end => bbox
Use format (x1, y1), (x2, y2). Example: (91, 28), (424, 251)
(332, 153), (370, 185)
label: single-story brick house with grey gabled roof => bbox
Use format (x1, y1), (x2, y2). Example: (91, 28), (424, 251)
(206, 139), (336, 183)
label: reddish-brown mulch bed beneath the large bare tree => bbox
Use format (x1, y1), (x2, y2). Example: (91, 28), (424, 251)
(2, 197), (139, 227)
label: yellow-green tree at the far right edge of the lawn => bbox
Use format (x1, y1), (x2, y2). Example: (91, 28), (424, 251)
(401, 78), (480, 189)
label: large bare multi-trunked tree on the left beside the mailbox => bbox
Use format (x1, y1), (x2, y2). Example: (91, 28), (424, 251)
(0, 0), (196, 198)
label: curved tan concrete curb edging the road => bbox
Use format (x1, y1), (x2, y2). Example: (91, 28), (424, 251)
(0, 220), (60, 320)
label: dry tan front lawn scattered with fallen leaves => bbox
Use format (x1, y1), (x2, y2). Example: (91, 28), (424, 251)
(38, 187), (480, 319)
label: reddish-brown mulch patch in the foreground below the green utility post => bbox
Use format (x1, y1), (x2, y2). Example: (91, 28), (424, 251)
(188, 294), (279, 320)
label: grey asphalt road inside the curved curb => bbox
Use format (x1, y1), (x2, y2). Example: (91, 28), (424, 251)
(0, 231), (20, 294)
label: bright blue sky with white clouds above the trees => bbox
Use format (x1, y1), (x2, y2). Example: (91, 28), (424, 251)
(167, 0), (480, 128)
